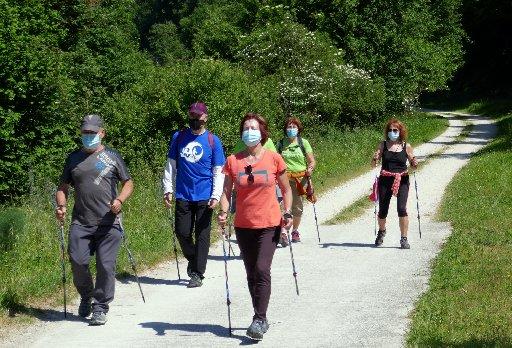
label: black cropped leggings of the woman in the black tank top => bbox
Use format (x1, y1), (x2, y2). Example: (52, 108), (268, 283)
(379, 175), (409, 219)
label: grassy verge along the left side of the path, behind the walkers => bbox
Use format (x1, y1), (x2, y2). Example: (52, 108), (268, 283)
(0, 110), (446, 326)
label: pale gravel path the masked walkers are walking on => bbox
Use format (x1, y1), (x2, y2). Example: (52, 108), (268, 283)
(0, 113), (496, 347)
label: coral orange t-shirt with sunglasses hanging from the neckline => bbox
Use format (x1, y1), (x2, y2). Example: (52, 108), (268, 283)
(223, 150), (286, 229)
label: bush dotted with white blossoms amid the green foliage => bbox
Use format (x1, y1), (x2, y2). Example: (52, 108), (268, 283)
(238, 20), (385, 124)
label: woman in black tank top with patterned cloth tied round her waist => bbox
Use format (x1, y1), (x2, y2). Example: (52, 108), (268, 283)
(372, 118), (418, 249)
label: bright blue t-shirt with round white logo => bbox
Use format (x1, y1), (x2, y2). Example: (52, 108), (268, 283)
(167, 128), (226, 202)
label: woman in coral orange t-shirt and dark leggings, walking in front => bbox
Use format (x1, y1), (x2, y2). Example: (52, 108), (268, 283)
(218, 113), (293, 340)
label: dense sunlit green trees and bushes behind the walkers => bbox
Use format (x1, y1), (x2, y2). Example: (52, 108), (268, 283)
(0, 0), (463, 201)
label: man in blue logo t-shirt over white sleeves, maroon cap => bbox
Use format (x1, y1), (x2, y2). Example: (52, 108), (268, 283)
(163, 102), (226, 288)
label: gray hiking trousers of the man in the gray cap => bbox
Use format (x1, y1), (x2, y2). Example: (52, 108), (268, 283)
(68, 224), (123, 313)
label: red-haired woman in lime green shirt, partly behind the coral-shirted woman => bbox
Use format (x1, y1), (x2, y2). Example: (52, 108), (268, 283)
(277, 116), (316, 246)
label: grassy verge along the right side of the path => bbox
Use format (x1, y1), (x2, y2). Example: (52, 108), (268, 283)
(407, 102), (512, 347)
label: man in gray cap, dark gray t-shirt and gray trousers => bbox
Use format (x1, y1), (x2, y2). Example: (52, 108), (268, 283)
(55, 115), (133, 325)
